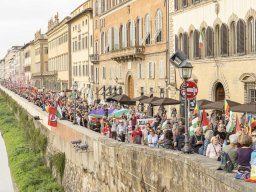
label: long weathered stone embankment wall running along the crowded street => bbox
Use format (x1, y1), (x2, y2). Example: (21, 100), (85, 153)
(0, 87), (255, 192)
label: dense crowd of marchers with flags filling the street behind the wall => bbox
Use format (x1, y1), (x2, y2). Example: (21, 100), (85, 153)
(3, 80), (256, 180)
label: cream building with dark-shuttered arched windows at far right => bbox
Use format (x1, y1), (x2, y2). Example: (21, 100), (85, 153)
(171, 0), (256, 103)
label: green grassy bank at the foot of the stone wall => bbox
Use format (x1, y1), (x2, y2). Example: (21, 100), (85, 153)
(0, 94), (63, 192)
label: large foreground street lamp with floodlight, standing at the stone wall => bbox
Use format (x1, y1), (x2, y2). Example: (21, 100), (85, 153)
(170, 51), (193, 153)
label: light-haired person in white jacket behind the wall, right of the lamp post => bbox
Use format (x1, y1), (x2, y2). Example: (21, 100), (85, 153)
(206, 137), (221, 160)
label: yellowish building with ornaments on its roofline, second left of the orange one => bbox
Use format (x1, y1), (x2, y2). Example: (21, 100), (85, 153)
(45, 14), (72, 91)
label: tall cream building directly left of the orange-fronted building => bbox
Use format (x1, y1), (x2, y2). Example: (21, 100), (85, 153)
(67, 0), (94, 100)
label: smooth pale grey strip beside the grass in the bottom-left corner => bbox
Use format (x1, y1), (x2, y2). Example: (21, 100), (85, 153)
(0, 134), (14, 192)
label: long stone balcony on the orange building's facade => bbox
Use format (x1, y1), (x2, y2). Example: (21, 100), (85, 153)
(111, 46), (145, 63)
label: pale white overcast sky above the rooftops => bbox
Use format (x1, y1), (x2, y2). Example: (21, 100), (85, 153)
(0, 0), (86, 59)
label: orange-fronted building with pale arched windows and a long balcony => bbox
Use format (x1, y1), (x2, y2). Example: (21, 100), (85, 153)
(91, 0), (170, 102)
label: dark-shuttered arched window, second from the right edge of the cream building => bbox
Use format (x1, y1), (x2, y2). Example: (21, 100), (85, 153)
(236, 19), (245, 54)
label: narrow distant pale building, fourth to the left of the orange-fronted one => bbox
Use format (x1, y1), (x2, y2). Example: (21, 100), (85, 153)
(22, 41), (35, 85)
